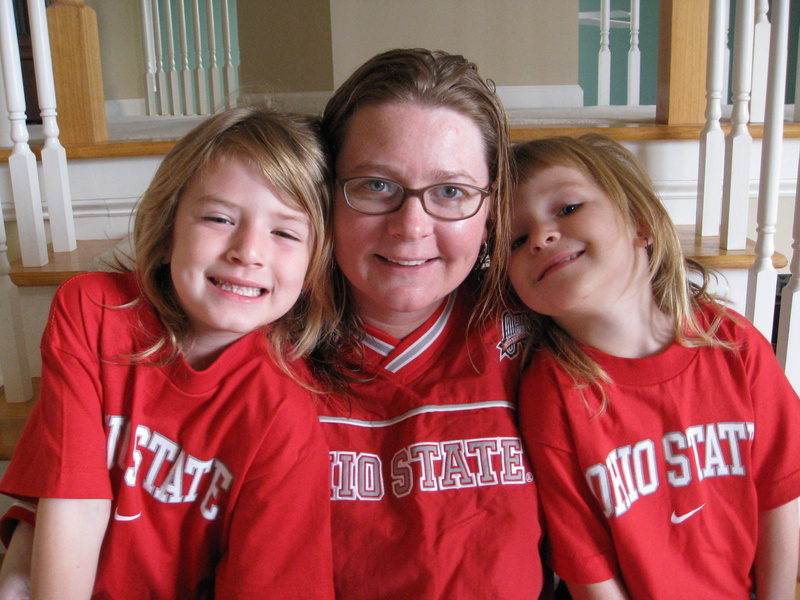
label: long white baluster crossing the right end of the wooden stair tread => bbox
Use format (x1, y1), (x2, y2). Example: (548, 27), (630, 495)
(745, 0), (789, 338)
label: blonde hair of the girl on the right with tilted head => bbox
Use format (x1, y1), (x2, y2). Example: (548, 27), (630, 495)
(507, 134), (728, 407)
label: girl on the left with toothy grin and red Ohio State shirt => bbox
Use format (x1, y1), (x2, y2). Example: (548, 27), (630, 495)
(2, 106), (333, 599)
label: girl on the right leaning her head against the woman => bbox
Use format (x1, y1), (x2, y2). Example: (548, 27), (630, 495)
(510, 135), (800, 600)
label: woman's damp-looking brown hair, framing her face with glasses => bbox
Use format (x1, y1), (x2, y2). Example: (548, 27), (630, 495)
(322, 48), (511, 332)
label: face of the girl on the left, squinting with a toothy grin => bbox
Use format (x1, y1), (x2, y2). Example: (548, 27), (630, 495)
(167, 156), (313, 359)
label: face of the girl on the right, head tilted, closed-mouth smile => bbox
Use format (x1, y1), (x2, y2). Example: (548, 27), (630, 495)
(510, 166), (649, 325)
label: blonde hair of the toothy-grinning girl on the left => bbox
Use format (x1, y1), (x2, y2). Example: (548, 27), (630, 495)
(133, 104), (337, 366)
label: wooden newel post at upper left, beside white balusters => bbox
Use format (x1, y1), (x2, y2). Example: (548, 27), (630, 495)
(47, 0), (108, 145)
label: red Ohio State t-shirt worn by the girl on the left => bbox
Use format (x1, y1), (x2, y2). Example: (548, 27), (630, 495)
(0, 273), (333, 599)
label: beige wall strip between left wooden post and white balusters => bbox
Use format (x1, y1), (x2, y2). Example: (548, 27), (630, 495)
(85, 0), (144, 100)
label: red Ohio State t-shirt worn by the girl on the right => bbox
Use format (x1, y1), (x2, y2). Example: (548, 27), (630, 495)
(520, 308), (800, 600)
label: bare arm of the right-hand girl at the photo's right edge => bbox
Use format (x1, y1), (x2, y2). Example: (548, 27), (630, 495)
(756, 500), (798, 600)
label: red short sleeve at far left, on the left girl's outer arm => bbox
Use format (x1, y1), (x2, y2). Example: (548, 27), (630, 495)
(0, 277), (112, 501)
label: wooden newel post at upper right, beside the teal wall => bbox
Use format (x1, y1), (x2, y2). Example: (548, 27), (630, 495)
(656, 0), (709, 125)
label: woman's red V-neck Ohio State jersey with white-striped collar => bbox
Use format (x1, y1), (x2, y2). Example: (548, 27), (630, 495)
(320, 294), (542, 600)
